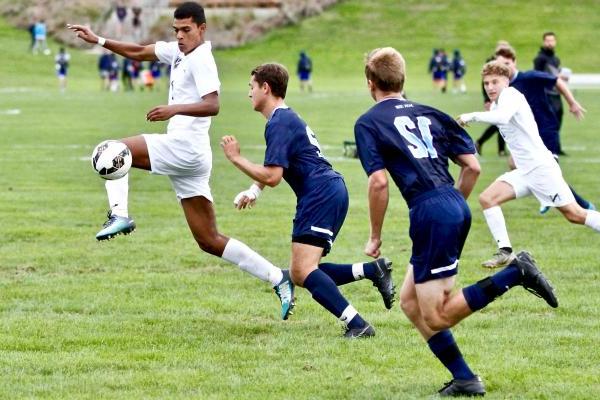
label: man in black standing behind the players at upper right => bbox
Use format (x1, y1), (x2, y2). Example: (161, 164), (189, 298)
(533, 32), (566, 155)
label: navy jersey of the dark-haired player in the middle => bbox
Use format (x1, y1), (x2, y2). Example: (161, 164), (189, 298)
(264, 108), (341, 201)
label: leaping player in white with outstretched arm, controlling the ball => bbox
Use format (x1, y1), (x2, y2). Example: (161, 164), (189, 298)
(68, 2), (294, 319)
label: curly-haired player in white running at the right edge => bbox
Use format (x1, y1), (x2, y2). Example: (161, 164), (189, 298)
(457, 61), (600, 268)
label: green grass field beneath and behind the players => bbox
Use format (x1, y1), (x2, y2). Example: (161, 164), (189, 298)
(0, 0), (600, 399)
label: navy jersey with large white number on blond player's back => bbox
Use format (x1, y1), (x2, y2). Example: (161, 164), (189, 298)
(354, 99), (475, 207)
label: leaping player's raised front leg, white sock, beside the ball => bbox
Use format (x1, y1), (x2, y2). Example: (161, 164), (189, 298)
(96, 135), (151, 240)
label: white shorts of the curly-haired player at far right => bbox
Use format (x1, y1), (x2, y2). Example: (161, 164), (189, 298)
(496, 164), (575, 207)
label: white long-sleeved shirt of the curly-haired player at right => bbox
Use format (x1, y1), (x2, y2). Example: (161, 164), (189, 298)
(460, 87), (555, 173)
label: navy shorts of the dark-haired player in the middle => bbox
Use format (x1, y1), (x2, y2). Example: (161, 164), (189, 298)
(292, 178), (348, 256)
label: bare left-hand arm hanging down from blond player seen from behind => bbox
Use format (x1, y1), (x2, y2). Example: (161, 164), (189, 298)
(365, 169), (389, 258)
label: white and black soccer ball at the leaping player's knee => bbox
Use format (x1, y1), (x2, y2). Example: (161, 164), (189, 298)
(92, 140), (131, 180)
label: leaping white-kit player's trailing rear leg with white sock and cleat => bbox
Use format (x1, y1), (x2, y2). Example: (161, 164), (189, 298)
(181, 196), (294, 319)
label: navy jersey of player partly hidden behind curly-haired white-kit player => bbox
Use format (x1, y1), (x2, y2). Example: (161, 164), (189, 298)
(510, 71), (560, 134)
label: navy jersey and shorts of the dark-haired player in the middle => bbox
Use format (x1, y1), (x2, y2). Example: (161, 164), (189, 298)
(264, 107), (348, 255)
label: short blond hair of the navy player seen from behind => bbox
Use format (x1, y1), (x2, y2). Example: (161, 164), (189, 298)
(365, 47), (406, 93)
